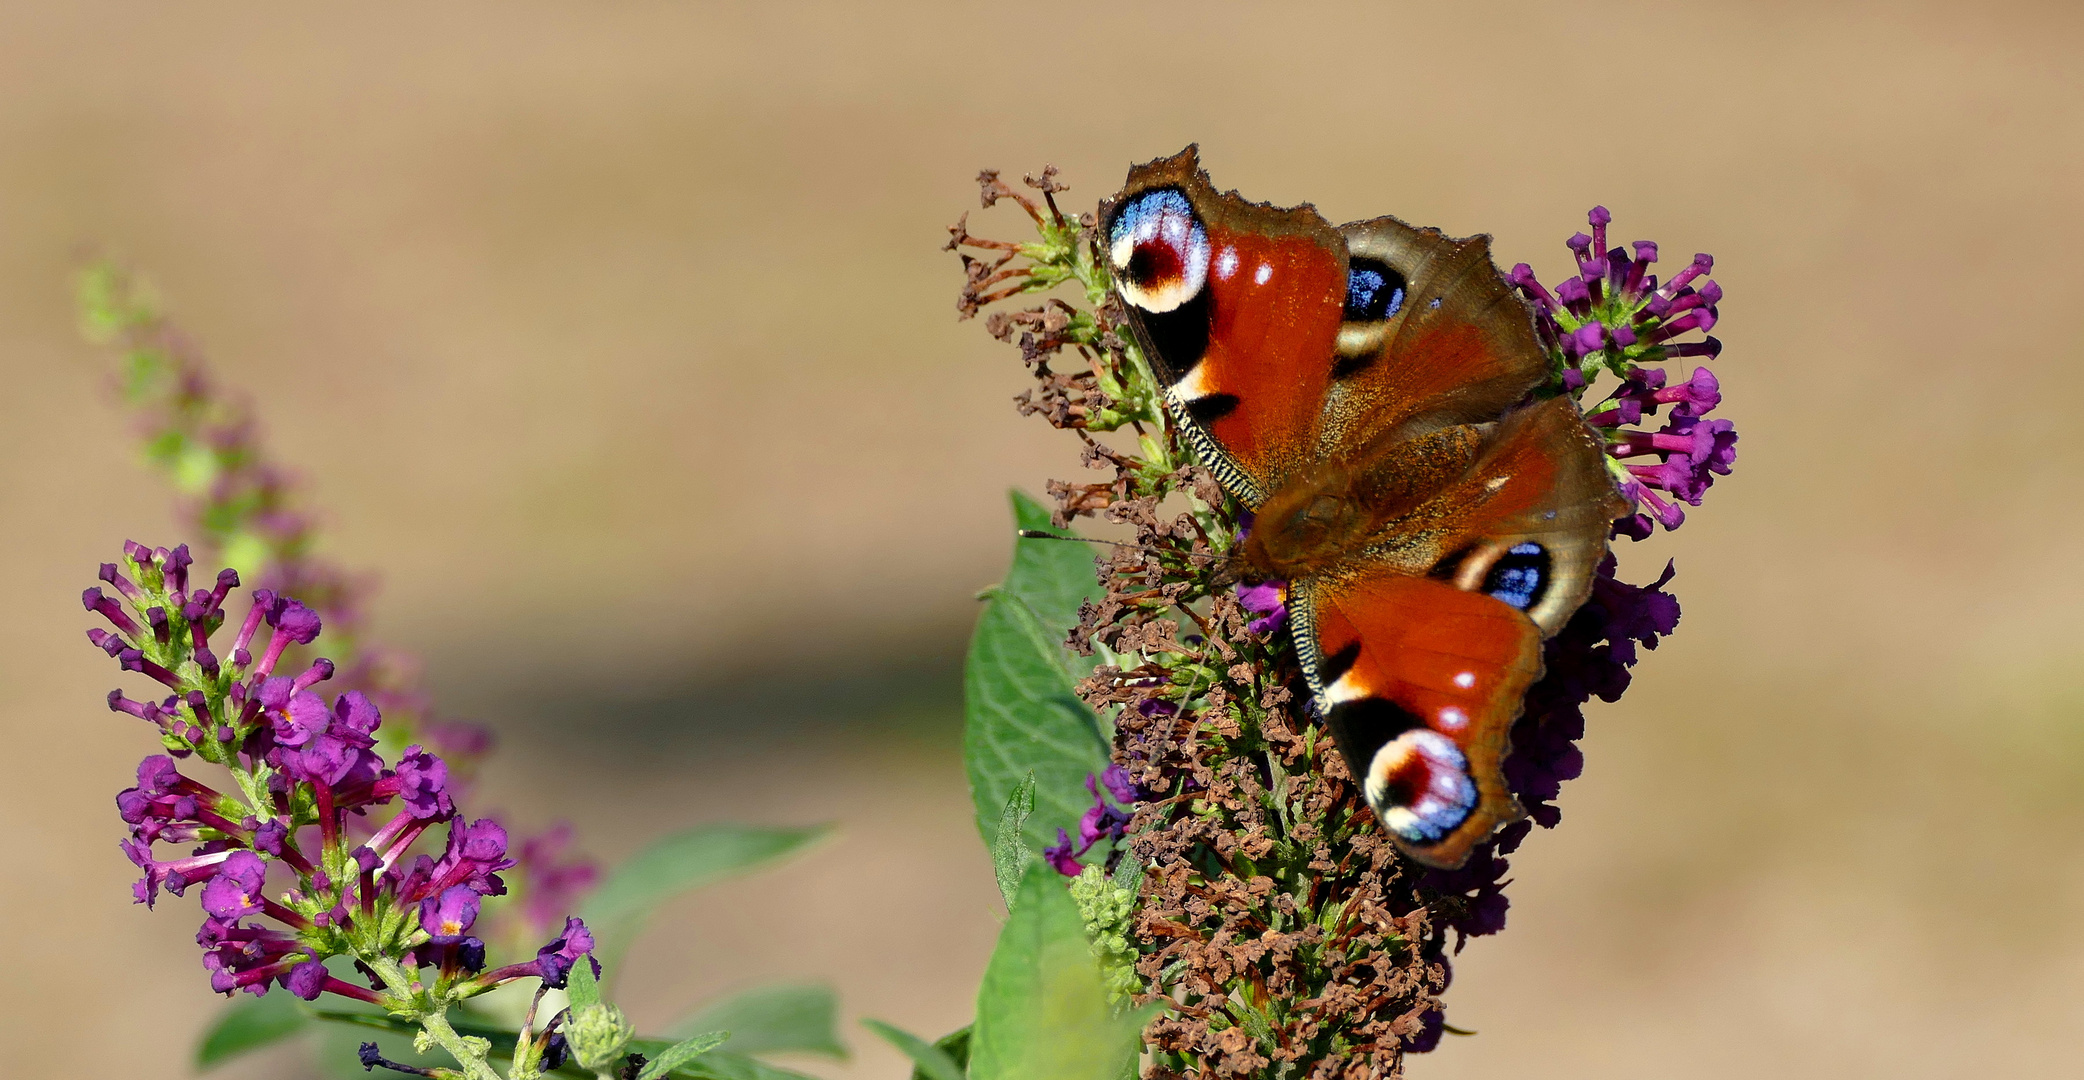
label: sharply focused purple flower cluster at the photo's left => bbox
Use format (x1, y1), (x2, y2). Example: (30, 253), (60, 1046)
(83, 544), (594, 1005)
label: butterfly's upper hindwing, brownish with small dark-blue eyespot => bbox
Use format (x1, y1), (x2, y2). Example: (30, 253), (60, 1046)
(1321, 217), (1548, 452)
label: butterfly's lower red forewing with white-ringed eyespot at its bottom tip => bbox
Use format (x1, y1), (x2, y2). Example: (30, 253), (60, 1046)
(1294, 573), (1542, 867)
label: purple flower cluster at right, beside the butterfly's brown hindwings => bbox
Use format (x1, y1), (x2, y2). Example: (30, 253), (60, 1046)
(1511, 206), (1736, 540)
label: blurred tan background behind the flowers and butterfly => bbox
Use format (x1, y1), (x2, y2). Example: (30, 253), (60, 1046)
(0, 2), (2084, 1080)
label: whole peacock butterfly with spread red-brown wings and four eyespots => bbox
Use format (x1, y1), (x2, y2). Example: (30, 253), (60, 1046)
(1100, 146), (1628, 867)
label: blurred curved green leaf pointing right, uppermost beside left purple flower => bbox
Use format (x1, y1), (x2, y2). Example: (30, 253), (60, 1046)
(581, 826), (832, 963)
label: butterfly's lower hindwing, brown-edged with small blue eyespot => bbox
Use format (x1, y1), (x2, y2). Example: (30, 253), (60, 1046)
(1419, 398), (1628, 638)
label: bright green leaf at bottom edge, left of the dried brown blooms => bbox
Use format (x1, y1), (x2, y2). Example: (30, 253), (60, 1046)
(969, 863), (1144, 1080)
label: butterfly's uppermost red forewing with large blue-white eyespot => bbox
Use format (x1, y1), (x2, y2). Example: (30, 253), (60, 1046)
(1100, 146), (1346, 507)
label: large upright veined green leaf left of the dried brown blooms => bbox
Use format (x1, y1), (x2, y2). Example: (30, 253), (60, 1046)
(963, 492), (1107, 867)
